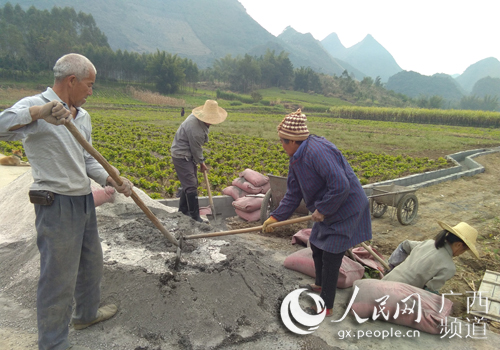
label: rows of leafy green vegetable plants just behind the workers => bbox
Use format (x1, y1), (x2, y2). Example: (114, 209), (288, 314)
(87, 111), (449, 198)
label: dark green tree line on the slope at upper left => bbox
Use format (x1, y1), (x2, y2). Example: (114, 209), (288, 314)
(0, 3), (199, 93)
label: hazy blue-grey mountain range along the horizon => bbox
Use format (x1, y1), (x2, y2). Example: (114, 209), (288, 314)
(0, 0), (500, 101)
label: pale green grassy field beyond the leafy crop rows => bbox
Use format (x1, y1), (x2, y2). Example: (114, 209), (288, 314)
(85, 85), (500, 158)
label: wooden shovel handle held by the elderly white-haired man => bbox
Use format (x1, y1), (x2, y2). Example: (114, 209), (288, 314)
(64, 123), (180, 247)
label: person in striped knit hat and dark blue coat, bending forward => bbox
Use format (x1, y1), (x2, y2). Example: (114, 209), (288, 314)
(262, 109), (372, 316)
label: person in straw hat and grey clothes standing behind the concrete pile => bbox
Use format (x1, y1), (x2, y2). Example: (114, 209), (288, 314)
(170, 100), (227, 222)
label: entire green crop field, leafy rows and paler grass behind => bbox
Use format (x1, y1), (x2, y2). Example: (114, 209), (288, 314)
(0, 84), (500, 198)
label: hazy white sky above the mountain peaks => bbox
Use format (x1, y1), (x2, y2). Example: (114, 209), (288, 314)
(239, 0), (500, 75)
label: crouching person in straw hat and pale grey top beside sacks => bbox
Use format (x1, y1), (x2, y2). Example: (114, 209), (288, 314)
(382, 221), (479, 293)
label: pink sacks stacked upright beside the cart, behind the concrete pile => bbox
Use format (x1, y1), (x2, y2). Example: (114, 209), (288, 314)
(222, 169), (271, 222)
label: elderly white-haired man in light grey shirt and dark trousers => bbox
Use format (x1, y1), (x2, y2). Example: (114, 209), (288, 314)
(0, 54), (133, 350)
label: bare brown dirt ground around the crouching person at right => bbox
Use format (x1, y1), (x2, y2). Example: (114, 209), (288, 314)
(230, 153), (500, 333)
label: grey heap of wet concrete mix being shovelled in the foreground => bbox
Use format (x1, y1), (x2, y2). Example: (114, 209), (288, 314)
(0, 176), (316, 350)
